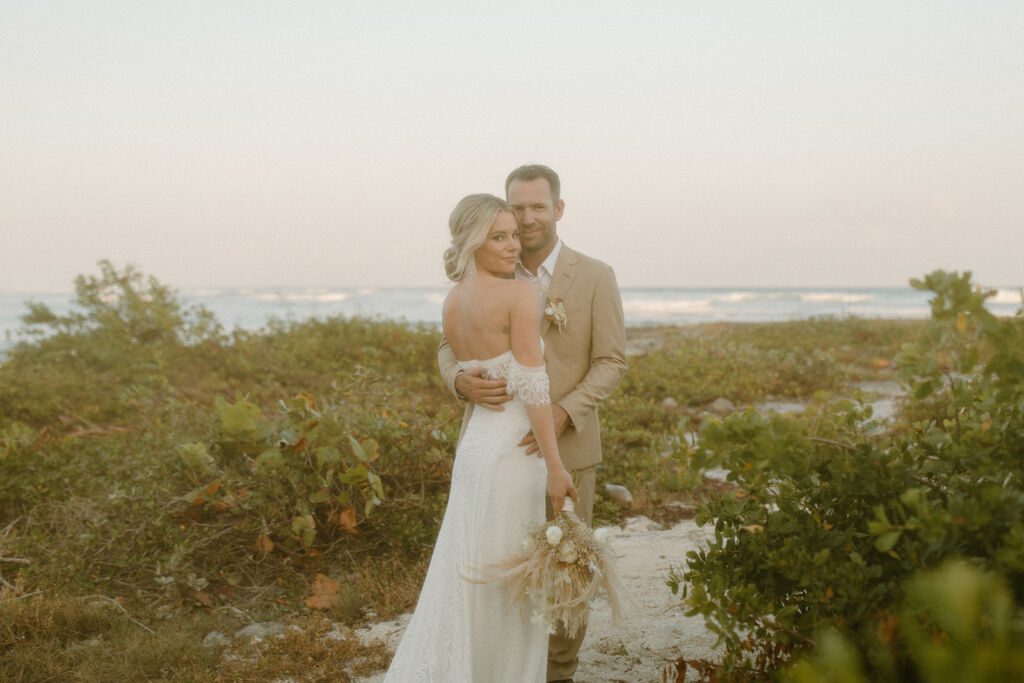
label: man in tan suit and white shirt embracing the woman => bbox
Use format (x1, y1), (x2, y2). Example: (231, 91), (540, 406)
(437, 164), (626, 681)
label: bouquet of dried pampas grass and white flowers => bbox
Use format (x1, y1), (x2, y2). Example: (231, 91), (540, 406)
(476, 498), (622, 638)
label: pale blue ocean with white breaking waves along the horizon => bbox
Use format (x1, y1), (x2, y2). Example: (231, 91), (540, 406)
(0, 287), (1022, 348)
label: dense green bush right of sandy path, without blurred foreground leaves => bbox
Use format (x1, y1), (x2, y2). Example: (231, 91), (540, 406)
(677, 272), (1024, 680)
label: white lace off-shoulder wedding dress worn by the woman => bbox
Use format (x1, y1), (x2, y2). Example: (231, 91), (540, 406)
(384, 351), (550, 683)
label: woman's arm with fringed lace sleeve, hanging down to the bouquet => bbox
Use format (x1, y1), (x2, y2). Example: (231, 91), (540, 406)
(509, 283), (577, 515)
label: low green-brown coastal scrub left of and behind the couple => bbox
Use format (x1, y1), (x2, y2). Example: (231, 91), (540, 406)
(0, 261), (942, 681)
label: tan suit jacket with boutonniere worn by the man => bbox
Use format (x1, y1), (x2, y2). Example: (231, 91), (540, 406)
(437, 243), (626, 471)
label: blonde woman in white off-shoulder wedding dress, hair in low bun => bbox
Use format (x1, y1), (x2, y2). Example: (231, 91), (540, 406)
(384, 195), (577, 683)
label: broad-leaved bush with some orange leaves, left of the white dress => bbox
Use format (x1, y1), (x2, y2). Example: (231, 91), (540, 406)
(179, 394), (384, 552)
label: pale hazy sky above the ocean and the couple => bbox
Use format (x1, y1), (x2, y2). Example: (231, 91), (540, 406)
(0, 0), (1024, 291)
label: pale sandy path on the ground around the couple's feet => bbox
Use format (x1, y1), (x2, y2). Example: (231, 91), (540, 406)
(359, 517), (715, 683)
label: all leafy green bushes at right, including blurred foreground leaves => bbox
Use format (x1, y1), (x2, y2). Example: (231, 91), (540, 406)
(671, 271), (1024, 681)
